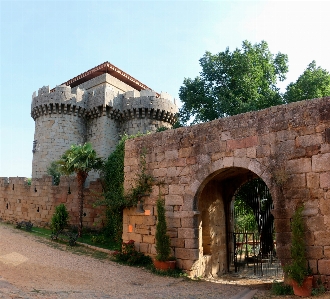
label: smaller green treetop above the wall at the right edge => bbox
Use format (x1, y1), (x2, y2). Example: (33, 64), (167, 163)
(284, 60), (330, 103)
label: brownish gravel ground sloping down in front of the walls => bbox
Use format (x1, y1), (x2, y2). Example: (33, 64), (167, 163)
(0, 223), (329, 299)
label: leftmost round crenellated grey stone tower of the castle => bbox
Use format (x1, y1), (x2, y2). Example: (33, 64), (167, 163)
(31, 86), (86, 178)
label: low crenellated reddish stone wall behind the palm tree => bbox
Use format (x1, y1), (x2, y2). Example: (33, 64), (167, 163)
(0, 176), (104, 228)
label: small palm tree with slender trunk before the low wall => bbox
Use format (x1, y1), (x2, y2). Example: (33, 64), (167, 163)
(56, 143), (103, 237)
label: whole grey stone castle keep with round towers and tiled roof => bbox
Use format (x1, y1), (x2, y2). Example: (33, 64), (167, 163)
(31, 62), (178, 178)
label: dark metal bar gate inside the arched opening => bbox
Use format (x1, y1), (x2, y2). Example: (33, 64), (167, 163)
(228, 178), (283, 277)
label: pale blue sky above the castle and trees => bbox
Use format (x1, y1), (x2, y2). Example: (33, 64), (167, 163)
(0, 0), (330, 177)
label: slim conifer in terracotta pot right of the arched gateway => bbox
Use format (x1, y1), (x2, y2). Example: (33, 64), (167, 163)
(284, 206), (313, 297)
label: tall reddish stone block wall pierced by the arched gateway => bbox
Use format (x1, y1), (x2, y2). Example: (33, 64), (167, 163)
(123, 98), (330, 284)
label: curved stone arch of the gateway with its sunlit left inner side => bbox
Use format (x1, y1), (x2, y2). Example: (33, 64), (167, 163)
(192, 158), (276, 276)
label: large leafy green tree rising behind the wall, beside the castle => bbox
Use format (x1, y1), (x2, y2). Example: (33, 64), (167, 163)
(179, 41), (288, 124)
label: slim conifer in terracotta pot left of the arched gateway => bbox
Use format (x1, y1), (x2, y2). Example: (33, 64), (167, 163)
(154, 192), (176, 270)
